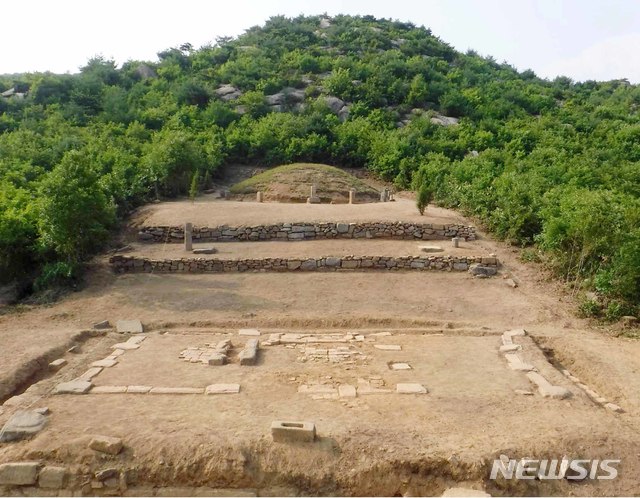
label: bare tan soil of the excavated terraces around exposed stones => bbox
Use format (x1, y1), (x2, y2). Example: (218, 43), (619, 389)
(0, 196), (640, 496)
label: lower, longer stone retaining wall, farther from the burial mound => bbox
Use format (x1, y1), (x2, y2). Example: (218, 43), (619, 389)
(109, 256), (498, 273)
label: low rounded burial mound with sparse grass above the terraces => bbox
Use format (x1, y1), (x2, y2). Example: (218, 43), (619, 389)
(230, 163), (379, 202)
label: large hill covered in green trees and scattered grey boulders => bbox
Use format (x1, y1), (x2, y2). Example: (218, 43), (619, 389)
(0, 15), (640, 318)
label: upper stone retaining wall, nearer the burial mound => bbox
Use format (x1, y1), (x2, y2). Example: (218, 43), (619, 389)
(138, 221), (476, 242)
